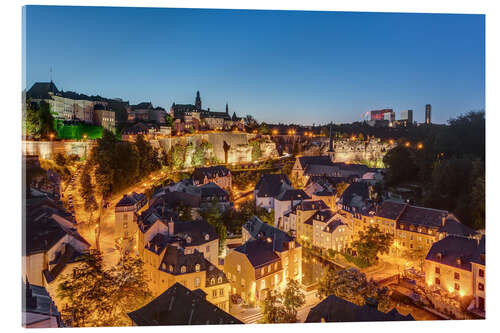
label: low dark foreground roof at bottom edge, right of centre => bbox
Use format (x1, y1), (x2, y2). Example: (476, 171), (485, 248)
(305, 295), (414, 323)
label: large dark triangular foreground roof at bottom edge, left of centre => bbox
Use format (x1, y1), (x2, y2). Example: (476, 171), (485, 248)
(128, 283), (243, 326)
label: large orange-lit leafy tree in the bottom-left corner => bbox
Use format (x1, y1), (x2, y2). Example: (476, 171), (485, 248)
(57, 250), (151, 327)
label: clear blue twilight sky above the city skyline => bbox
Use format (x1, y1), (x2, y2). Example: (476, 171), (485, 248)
(23, 6), (485, 124)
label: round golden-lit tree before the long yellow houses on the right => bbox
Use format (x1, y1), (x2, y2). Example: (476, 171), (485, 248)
(351, 226), (394, 265)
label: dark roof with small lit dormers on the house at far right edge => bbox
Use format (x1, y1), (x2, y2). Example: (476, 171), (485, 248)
(425, 236), (479, 271)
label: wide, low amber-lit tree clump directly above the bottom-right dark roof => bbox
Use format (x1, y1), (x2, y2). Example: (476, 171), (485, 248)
(316, 268), (392, 312)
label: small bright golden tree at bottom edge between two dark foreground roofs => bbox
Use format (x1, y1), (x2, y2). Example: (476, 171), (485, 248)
(261, 279), (305, 324)
